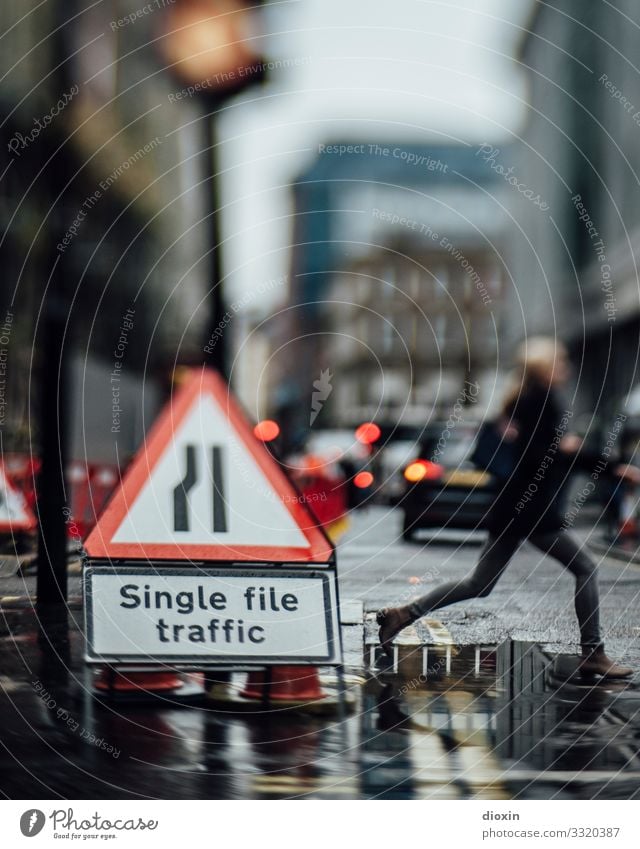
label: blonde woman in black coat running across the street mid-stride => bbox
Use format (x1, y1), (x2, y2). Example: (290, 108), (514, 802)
(377, 337), (640, 678)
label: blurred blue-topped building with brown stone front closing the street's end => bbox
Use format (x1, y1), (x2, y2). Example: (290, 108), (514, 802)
(274, 142), (510, 444)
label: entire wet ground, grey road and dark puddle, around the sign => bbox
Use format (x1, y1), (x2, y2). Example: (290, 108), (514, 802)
(0, 507), (640, 799)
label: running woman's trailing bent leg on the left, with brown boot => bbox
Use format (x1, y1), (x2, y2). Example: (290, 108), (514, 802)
(376, 535), (521, 654)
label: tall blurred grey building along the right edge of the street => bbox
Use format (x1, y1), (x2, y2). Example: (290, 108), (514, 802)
(508, 0), (640, 421)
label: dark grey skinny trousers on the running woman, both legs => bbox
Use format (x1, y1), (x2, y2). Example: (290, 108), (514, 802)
(409, 530), (601, 646)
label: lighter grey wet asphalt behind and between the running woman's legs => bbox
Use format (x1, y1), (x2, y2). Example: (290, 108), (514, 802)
(338, 507), (640, 670)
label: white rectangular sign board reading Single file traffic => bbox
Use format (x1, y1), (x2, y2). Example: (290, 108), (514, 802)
(89, 564), (342, 666)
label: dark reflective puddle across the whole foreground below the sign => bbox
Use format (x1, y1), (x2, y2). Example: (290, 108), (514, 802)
(0, 615), (640, 799)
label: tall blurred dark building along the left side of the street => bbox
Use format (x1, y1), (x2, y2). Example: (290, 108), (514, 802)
(0, 0), (210, 461)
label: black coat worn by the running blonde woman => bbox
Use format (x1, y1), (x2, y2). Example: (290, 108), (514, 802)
(487, 385), (611, 537)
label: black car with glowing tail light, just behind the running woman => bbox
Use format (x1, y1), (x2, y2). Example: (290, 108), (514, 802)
(399, 423), (496, 540)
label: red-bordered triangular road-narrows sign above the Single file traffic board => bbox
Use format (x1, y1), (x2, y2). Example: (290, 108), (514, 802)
(85, 369), (333, 563)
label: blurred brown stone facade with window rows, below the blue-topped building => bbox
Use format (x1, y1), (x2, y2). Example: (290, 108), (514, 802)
(320, 240), (504, 426)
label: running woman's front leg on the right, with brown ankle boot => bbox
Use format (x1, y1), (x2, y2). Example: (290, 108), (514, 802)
(529, 529), (633, 678)
